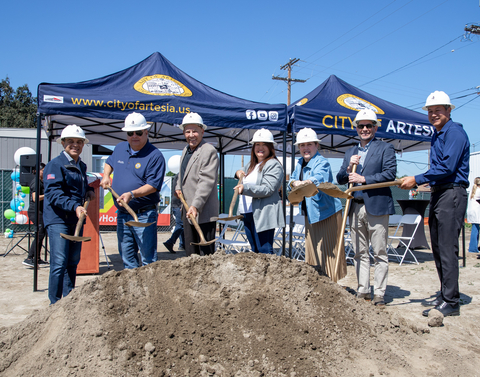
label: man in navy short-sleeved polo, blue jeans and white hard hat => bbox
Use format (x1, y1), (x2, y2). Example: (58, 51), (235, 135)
(101, 113), (165, 269)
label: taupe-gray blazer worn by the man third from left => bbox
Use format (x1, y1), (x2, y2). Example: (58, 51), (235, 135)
(175, 140), (219, 224)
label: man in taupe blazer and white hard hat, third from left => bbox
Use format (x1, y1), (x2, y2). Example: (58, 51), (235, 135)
(175, 113), (219, 256)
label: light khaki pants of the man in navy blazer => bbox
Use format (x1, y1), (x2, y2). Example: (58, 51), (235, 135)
(349, 202), (389, 297)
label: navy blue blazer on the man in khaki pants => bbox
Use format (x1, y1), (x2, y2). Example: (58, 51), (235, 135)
(337, 139), (397, 216)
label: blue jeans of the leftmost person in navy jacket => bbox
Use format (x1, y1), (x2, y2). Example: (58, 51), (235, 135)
(47, 224), (83, 304)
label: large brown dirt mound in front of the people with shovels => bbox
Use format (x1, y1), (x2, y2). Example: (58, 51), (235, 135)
(0, 253), (428, 377)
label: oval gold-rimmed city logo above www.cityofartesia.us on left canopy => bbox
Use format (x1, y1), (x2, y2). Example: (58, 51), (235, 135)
(133, 75), (192, 97)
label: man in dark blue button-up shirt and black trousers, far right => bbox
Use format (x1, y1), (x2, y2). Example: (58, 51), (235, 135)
(400, 91), (470, 317)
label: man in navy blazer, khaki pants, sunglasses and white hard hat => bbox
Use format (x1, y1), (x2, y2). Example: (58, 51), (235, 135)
(337, 109), (397, 307)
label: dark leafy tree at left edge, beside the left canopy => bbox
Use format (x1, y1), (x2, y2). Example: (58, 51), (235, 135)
(0, 76), (37, 128)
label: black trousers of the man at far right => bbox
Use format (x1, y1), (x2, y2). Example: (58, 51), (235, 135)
(428, 187), (468, 306)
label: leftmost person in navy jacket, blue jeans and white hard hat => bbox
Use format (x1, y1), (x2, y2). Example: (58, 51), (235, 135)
(43, 125), (95, 304)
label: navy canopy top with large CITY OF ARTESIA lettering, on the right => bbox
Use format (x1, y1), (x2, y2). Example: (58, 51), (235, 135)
(288, 75), (434, 158)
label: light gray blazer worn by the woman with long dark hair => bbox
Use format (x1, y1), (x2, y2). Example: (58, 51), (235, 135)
(242, 159), (285, 232)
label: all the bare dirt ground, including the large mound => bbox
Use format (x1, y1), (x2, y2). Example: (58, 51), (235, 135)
(0, 233), (480, 377)
